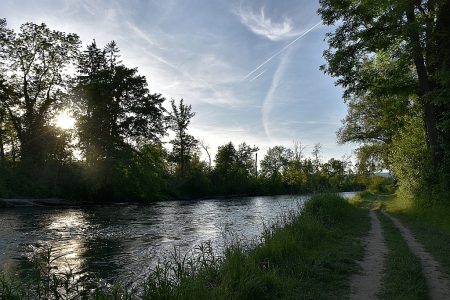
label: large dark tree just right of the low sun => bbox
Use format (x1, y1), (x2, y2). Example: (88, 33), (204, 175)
(73, 41), (166, 165)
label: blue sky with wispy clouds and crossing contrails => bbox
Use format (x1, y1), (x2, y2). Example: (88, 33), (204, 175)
(0, 0), (355, 160)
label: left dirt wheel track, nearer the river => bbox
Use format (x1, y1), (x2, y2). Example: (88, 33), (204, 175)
(350, 211), (388, 299)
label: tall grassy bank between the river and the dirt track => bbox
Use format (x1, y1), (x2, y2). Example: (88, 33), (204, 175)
(0, 195), (370, 299)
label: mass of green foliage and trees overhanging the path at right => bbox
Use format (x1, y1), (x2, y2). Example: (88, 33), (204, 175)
(319, 0), (450, 205)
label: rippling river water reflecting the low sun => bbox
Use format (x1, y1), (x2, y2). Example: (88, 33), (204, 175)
(0, 193), (353, 283)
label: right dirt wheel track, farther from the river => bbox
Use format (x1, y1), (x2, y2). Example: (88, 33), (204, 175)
(383, 211), (450, 300)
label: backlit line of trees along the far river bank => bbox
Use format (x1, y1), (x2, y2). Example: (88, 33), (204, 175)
(0, 19), (367, 201)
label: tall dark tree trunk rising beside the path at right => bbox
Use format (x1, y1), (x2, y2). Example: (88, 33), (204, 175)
(406, 1), (441, 171)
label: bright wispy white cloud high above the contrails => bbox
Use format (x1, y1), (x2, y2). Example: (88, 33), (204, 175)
(236, 7), (298, 41)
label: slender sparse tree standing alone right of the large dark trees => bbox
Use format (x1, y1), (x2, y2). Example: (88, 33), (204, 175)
(169, 99), (198, 176)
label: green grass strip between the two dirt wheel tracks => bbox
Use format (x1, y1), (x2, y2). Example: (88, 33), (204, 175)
(377, 212), (428, 300)
